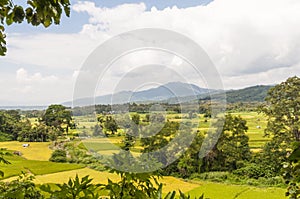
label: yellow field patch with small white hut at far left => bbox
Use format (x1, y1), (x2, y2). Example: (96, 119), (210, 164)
(0, 141), (52, 161)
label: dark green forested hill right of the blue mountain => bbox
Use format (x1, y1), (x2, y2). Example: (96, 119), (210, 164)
(205, 85), (273, 103)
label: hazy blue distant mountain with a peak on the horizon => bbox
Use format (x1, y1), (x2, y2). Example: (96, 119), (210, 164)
(67, 82), (213, 106)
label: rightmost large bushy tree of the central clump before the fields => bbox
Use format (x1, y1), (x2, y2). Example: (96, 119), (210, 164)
(202, 114), (251, 171)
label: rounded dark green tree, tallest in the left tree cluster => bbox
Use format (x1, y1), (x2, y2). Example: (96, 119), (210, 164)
(42, 104), (72, 133)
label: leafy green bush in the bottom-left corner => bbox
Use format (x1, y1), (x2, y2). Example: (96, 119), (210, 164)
(0, 173), (44, 199)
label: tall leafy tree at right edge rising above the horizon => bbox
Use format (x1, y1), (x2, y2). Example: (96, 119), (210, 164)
(260, 76), (300, 143)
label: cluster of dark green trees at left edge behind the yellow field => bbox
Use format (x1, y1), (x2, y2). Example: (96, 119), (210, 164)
(0, 105), (75, 142)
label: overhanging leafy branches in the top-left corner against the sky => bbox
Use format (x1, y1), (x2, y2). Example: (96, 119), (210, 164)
(0, 0), (70, 56)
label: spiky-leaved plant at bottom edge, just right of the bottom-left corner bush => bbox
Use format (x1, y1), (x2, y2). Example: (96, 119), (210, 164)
(40, 175), (99, 199)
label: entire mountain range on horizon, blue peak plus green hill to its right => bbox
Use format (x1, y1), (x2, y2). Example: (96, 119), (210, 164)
(63, 82), (272, 106)
